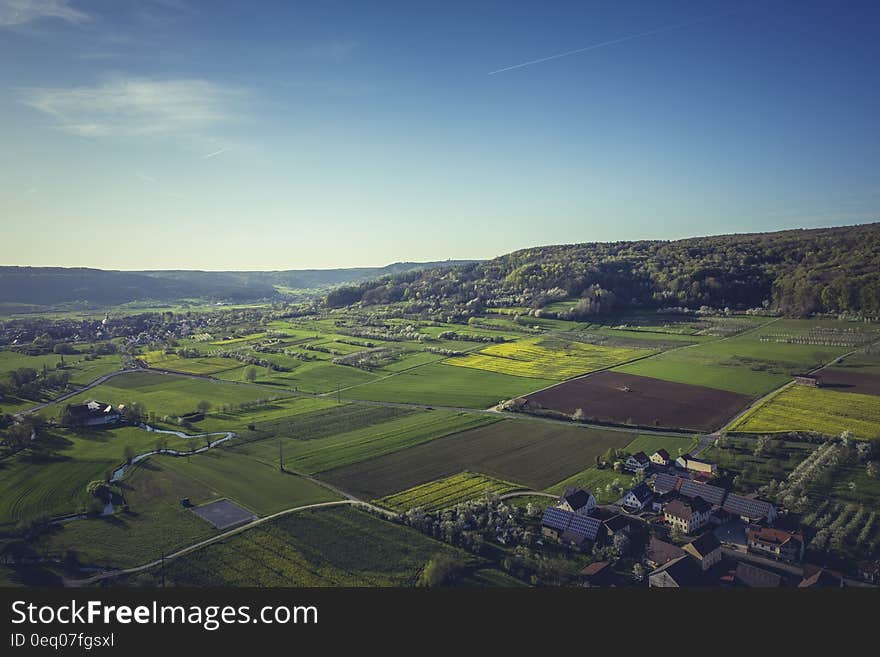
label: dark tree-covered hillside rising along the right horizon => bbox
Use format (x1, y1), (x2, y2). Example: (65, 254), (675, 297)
(327, 223), (880, 316)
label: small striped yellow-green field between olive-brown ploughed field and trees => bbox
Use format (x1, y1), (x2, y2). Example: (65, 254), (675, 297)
(376, 472), (520, 513)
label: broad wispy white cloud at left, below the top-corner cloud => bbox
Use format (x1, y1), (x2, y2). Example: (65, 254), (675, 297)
(21, 78), (243, 137)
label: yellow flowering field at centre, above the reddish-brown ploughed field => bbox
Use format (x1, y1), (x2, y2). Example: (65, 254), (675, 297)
(447, 337), (651, 381)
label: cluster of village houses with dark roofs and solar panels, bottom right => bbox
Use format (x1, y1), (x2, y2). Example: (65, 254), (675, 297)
(541, 450), (856, 588)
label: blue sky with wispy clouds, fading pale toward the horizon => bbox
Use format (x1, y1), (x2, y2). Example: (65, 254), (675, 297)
(0, 0), (880, 269)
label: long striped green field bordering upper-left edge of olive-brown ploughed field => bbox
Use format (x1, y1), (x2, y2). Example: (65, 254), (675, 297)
(233, 411), (497, 474)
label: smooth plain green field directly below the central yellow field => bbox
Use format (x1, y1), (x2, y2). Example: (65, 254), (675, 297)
(343, 359), (554, 408)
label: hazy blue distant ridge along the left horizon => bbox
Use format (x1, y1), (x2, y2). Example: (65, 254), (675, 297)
(0, 260), (467, 306)
